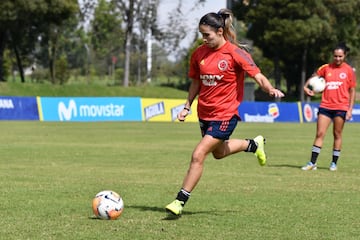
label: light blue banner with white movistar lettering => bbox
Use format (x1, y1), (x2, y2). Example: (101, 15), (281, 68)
(40, 97), (142, 121)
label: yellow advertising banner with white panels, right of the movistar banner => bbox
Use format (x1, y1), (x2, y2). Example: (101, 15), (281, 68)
(141, 98), (198, 122)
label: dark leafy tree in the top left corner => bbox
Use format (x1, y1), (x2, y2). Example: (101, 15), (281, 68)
(0, 0), (78, 82)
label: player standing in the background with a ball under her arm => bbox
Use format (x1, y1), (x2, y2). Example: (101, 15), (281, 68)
(302, 43), (356, 171)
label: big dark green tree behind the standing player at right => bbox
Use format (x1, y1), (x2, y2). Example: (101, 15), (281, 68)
(233, 0), (360, 100)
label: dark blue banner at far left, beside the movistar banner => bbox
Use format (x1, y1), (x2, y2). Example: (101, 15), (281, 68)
(0, 97), (39, 120)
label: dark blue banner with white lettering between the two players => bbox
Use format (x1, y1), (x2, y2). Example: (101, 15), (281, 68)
(239, 102), (301, 123)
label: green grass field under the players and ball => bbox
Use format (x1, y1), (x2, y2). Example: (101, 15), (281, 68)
(0, 121), (360, 240)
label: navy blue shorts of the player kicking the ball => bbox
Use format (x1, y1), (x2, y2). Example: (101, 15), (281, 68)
(199, 115), (239, 140)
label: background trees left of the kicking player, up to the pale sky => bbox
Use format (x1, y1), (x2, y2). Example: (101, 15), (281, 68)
(0, 0), (204, 86)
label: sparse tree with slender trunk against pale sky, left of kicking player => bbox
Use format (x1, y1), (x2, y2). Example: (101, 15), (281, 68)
(83, 0), (205, 87)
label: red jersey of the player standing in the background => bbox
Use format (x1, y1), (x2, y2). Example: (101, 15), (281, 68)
(316, 63), (356, 111)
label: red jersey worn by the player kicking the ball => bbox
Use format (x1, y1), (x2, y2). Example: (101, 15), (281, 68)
(189, 42), (260, 121)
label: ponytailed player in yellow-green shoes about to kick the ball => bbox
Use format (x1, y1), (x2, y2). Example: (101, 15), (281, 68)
(166, 9), (284, 216)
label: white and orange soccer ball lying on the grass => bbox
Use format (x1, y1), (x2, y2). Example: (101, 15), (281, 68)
(92, 190), (124, 220)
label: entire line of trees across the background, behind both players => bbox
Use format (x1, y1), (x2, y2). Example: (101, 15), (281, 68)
(0, 0), (360, 100)
